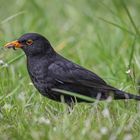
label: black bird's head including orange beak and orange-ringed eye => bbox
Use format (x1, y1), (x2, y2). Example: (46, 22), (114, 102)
(4, 33), (53, 56)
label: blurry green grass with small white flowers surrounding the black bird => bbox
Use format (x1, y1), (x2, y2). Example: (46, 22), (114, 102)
(0, 0), (140, 140)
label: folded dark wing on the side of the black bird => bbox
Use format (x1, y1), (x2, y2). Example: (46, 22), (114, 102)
(48, 61), (113, 90)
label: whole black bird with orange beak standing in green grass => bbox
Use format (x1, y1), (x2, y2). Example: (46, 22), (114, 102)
(5, 33), (140, 104)
